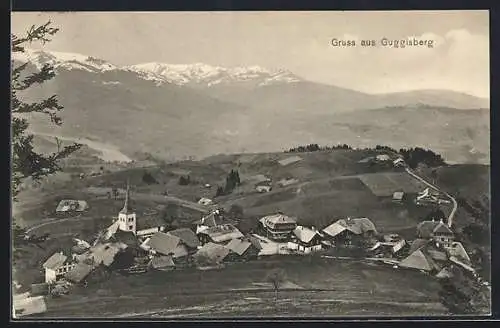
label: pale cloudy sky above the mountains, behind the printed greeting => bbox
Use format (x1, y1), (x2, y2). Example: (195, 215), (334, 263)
(11, 11), (490, 98)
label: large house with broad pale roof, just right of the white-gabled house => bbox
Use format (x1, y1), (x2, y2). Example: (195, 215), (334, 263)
(323, 218), (377, 246)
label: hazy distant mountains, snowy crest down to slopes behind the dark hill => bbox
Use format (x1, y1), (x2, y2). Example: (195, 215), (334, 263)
(13, 50), (489, 163)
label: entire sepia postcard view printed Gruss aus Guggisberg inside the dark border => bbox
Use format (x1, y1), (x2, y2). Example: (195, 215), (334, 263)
(10, 10), (492, 321)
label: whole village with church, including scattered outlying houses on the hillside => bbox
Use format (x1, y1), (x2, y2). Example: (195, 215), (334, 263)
(11, 155), (487, 314)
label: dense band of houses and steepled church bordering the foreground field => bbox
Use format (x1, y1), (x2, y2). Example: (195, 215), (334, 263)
(43, 169), (473, 292)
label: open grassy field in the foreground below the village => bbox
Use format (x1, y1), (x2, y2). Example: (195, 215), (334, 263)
(32, 257), (445, 318)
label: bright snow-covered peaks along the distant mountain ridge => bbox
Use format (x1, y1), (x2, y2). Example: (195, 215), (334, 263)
(12, 49), (301, 87)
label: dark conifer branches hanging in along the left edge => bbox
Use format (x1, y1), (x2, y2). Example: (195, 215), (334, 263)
(11, 21), (81, 232)
